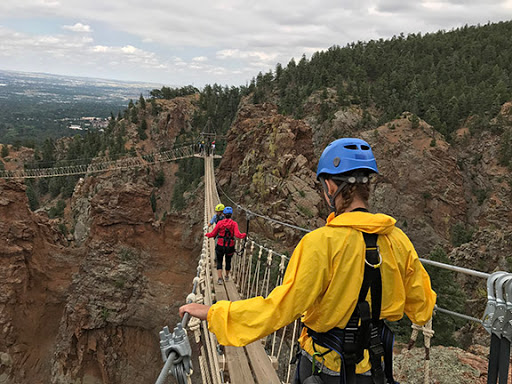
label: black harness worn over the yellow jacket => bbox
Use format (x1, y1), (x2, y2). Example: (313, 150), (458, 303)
(307, 232), (395, 384)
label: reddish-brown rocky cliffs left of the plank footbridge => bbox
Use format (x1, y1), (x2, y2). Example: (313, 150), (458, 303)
(0, 98), (202, 384)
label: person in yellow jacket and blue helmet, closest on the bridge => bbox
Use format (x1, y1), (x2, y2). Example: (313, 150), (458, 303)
(180, 138), (436, 384)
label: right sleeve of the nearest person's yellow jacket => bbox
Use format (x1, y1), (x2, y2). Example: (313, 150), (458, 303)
(404, 236), (437, 325)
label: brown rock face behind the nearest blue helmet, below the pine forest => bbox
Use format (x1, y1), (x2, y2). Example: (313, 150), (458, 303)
(218, 103), (512, 260)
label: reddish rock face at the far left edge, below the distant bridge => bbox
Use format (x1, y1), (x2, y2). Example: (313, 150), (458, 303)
(0, 180), (80, 383)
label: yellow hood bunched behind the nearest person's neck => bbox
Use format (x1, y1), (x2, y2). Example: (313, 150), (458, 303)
(326, 211), (396, 235)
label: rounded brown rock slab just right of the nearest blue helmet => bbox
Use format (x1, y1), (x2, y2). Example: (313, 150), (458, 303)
(361, 114), (467, 255)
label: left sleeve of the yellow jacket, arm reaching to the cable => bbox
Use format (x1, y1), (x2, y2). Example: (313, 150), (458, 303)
(207, 233), (329, 347)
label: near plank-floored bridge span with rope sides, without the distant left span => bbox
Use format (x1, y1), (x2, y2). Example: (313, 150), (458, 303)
(156, 148), (512, 384)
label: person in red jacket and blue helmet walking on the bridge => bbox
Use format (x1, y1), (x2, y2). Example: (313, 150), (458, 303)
(205, 207), (247, 284)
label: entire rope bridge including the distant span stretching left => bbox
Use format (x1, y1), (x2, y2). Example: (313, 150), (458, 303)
(0, 146), (512, 384)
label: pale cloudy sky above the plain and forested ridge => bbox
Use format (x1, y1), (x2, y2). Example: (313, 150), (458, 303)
(0, 0), (512, 88)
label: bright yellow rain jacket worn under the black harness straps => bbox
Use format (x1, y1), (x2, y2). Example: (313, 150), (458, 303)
(208, 211), (436, 373)
